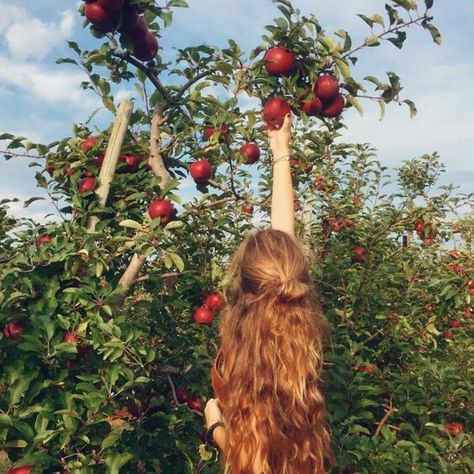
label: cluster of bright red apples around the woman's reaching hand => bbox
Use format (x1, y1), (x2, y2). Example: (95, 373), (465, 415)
(263, 46), (345, 128)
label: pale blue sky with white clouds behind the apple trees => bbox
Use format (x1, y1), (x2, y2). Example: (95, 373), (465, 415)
(0, 0), (474, 220)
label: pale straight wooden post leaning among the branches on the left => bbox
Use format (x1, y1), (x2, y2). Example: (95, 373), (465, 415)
(87, 100), (133, 232)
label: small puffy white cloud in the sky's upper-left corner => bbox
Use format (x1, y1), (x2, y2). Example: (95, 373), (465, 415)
(5, 10), (75, 61)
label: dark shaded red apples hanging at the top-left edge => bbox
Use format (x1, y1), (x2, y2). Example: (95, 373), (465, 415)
(84, 0), (158, 61)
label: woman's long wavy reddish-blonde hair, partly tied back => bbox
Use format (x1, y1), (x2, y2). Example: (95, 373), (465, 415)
(219, 229), (334, 474)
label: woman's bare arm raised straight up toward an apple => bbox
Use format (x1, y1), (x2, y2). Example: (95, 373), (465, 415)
(267, 114), (295, 237)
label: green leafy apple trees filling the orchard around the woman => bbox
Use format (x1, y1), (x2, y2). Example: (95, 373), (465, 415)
(0, 0), (474, 473)
